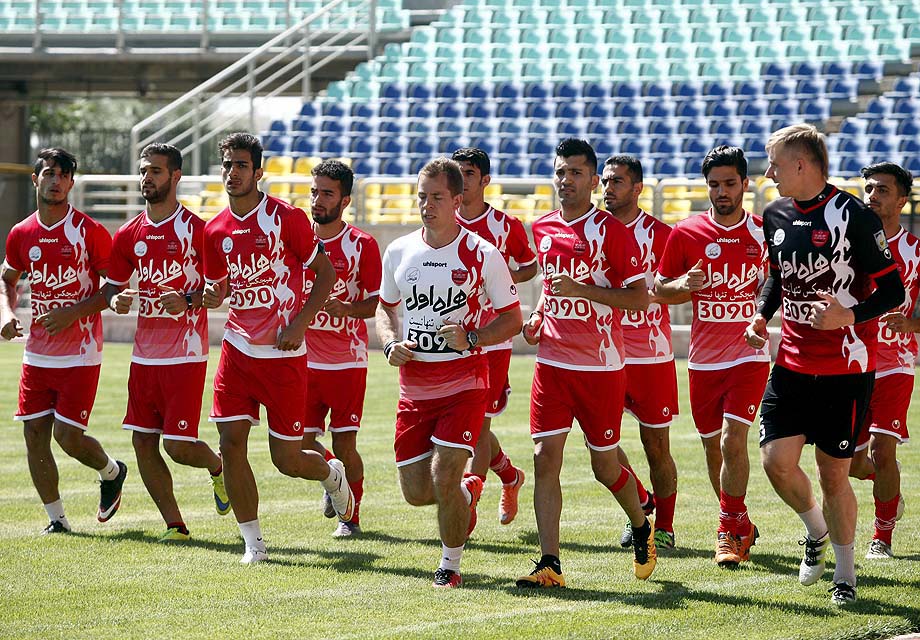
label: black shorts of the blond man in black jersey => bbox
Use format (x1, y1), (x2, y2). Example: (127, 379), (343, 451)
(760, 366), (875, 458)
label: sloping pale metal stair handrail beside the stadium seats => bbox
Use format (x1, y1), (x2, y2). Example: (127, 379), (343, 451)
(130, 0), (377, 173)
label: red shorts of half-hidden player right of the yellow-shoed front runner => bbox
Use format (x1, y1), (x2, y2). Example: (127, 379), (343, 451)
(625, 360), (680, 428)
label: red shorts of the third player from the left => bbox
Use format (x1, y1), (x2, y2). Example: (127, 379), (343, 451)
(211, 340), (307, 440)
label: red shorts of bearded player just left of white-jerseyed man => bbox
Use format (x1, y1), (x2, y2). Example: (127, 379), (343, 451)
(304, 367), (367, 434)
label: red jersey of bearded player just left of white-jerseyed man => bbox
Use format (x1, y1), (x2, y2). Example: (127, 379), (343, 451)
(304, 224), (382, 369)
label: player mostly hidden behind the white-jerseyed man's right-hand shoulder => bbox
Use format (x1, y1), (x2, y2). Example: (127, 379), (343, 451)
(451, 148), (538, 524)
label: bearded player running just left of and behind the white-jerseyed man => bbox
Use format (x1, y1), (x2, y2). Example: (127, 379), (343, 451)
(303, 160), (381, 538)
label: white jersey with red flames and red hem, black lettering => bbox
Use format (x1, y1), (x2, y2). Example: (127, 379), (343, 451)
(380, 229), (520, 400)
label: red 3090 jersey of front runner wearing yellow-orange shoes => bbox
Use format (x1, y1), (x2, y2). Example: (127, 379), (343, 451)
(533, 207), (645, 371)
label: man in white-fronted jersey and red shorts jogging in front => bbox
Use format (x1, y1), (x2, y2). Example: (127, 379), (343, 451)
(377, 158), (521, 588)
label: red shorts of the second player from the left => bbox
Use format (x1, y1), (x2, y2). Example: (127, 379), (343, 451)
(122, 362), (208, 442)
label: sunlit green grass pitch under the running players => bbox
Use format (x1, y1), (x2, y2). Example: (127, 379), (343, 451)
(0, 344), (920, 640)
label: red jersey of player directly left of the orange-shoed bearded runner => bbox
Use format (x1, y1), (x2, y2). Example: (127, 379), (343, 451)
(622, 211), (674, 364)
